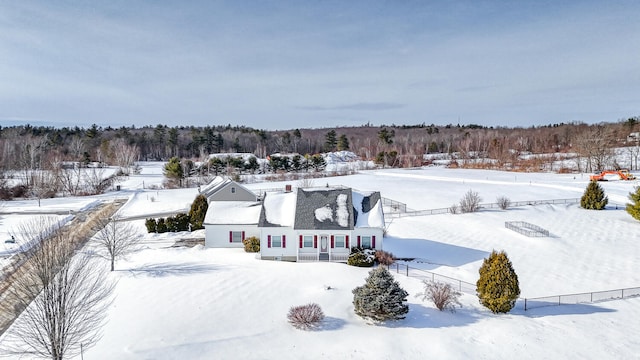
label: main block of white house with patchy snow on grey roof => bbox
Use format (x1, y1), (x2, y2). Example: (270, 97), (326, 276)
(258, 188), (384, 261)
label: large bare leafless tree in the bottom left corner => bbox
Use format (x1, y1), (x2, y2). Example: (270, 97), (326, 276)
(0, 218), (114, 360)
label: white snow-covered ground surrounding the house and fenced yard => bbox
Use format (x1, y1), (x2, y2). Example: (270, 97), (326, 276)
(0, 165), (640, 359)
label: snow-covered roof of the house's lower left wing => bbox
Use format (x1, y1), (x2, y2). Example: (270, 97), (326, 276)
(204, 201), (261, 225)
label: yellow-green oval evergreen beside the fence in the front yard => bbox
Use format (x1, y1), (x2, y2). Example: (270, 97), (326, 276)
(476, 250), (520, 313)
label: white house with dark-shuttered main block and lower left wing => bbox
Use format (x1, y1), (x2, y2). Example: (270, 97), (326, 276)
(203, 180), (384, 261)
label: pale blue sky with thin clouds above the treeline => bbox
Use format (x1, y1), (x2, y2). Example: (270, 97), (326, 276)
(0, 0), (640, 129)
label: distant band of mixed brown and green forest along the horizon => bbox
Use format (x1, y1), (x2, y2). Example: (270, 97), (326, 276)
(0, 117), (640, 171)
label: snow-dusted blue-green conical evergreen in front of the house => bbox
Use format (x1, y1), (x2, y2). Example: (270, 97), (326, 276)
(352, 267), (409, 321)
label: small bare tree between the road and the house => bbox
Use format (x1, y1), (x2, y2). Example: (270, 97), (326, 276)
(95, 218), (140, 271)
